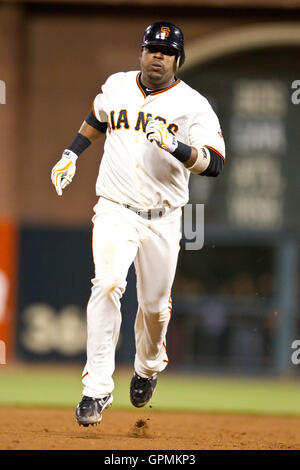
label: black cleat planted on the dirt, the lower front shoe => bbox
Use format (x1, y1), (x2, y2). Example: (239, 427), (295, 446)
(76, 395), (113, 426)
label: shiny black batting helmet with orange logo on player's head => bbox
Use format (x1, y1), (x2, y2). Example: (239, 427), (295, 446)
(142, 21), (185, 67)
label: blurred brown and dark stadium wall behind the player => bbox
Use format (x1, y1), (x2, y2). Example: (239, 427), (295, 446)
(0, 0), (300, 375)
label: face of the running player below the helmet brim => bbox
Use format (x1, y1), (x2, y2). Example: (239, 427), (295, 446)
(140, 45), (176, 88)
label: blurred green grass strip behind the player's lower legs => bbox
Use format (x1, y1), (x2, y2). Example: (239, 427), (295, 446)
(0, 364), (300, 415)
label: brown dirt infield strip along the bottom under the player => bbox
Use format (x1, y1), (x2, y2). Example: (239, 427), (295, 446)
(0, 407), (300, 450)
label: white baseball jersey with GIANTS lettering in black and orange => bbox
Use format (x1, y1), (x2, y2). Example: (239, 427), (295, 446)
(93, 71), (225, 209)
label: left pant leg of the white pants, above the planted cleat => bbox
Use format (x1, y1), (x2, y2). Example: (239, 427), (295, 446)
(82, 198), (137, 398)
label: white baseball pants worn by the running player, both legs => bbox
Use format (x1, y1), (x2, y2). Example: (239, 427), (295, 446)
(82, 198), (181, 398)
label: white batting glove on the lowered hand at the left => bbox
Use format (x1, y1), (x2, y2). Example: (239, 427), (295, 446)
(51, 149), (78, 196)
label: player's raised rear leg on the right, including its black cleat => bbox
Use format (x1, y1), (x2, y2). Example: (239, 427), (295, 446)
(131, 208), (181, 406)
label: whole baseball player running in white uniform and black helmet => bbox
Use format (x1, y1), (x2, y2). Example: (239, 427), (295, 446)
(51, 22), (225, 426)
